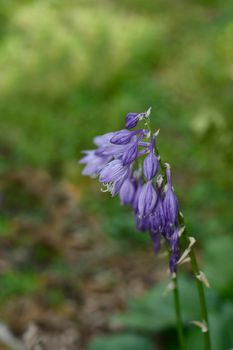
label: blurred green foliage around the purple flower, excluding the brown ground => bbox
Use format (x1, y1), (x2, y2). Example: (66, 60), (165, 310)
(0, 0), (233, 350)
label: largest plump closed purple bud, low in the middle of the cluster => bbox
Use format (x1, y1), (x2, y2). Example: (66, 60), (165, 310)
(138, 181), (157, 217)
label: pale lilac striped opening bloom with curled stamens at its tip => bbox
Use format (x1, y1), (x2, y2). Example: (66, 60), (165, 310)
(99, 159), (130, 183)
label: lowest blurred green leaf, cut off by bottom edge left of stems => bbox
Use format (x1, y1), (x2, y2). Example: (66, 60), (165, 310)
(87, 334), (155, 350)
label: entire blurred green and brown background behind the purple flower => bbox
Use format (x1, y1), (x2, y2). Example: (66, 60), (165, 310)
(0, 0), (233, 350)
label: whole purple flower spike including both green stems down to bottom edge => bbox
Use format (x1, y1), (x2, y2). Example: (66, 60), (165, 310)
(80, 108), (211, 350)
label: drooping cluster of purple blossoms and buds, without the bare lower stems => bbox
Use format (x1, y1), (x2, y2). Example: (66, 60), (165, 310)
(80, 109), (179, 272)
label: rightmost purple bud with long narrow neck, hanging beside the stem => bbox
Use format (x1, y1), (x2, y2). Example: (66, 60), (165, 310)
(163, 166), (179, 225)
